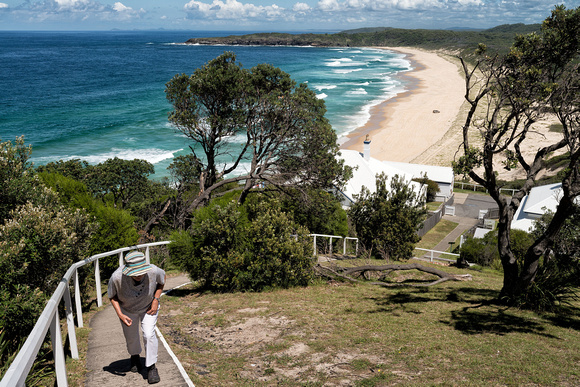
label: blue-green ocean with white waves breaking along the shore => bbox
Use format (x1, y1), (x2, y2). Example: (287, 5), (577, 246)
(0, 31), (411, 177)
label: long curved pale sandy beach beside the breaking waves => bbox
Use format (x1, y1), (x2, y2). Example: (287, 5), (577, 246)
(341, 47), (465, 165)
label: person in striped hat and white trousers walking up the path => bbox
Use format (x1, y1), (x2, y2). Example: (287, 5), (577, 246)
(107, 251), (166, 384)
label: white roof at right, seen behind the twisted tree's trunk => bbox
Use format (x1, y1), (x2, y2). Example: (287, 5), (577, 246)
(511, 183), (562, 231)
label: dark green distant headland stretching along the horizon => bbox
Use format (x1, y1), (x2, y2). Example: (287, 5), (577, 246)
(185, 24), (540, 50)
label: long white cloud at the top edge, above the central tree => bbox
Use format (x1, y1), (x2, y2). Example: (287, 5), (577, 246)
(184, 0), (284, 20)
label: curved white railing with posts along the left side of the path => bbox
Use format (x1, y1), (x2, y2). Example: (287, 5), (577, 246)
(0, 241), (171, 387)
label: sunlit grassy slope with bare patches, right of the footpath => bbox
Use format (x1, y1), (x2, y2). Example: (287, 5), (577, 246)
(158, 267), (580, 386)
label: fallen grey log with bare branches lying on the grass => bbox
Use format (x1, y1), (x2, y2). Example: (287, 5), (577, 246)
(314, 263), (472, 287)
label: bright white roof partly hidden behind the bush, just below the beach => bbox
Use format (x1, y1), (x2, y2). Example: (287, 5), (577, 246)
(338, 149), (422, 205)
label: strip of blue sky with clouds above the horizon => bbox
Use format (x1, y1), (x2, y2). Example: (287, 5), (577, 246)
(0, 0), (580, 32)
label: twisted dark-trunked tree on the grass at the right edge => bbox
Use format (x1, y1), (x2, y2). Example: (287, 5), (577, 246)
(454, 6), (580, 302)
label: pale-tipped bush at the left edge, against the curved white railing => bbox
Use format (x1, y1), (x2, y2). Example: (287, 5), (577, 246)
(0, 202), (93, 378)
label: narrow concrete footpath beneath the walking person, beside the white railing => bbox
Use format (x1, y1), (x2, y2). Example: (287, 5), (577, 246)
(85, 275), (192, 387)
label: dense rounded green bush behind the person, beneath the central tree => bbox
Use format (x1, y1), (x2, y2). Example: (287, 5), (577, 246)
(169, 201), (312, 292)
